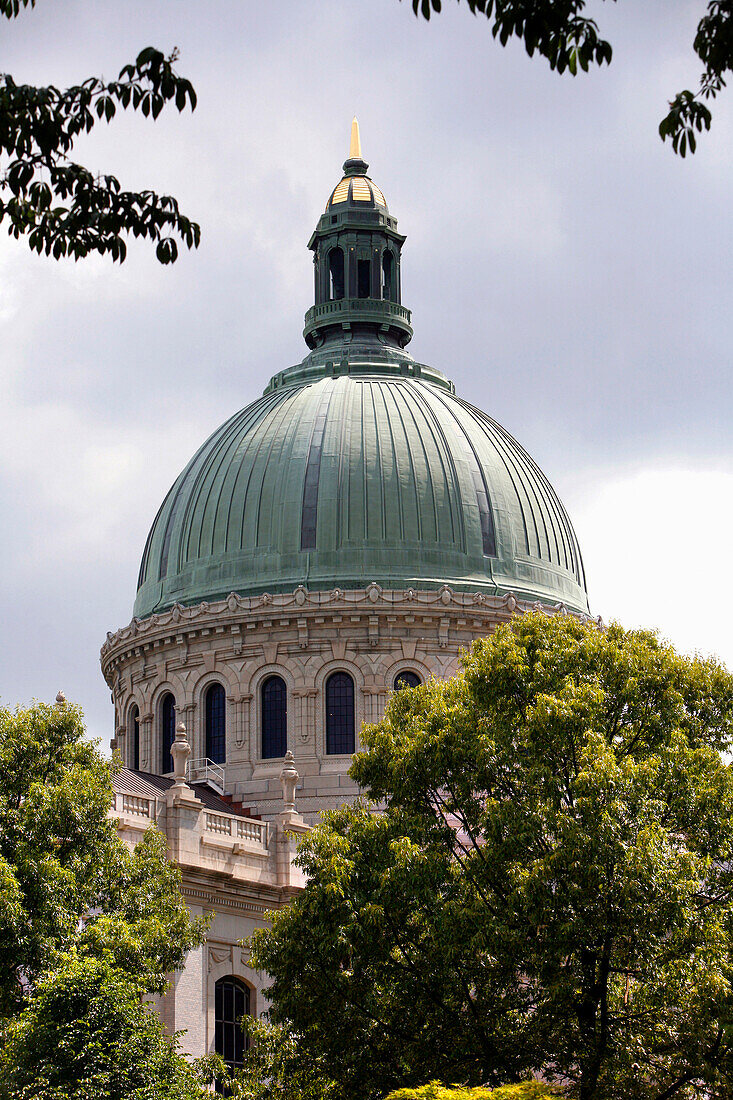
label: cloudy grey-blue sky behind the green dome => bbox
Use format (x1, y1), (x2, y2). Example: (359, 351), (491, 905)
(0, 0), (733, 744)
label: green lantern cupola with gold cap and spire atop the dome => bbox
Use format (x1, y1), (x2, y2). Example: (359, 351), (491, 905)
(303, 118), (413, 349)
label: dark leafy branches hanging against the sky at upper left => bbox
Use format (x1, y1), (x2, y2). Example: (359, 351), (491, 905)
(0, 0), (200, 264)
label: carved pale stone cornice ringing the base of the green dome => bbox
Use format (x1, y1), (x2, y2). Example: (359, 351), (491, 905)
(100, 583), (601, 675)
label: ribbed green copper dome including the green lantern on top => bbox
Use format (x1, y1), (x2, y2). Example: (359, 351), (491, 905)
(134, 125), (588, 617)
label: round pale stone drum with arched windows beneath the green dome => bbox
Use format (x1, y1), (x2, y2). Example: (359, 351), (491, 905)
(101, 584), (594, 823)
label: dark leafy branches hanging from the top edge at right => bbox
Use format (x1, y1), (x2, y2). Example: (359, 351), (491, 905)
(405, 0), (733, 156)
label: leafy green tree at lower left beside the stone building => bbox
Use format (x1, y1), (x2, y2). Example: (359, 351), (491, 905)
(0, 703), (205, 1100)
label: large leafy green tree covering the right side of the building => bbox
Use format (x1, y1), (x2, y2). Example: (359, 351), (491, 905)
(252, 614), (733, 1100)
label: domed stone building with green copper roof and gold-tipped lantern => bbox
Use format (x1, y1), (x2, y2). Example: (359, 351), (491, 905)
(101, 120), (588, 1073)
